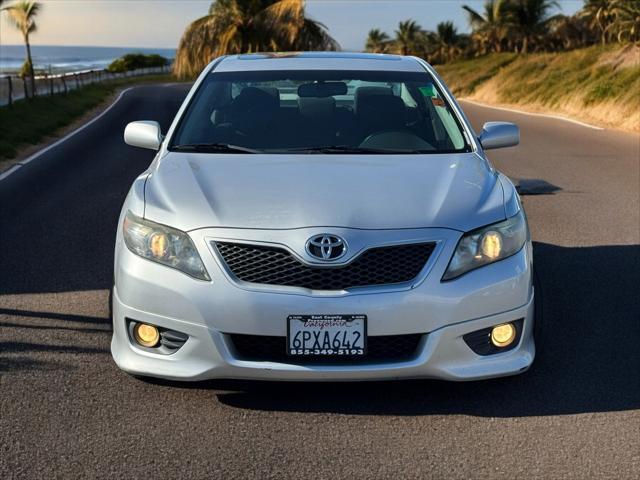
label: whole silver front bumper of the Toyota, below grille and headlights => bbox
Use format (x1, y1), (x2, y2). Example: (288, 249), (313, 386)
(111, 226), (535, 381)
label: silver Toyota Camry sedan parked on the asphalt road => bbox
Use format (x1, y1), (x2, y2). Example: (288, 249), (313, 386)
(111, 53), (535, 381)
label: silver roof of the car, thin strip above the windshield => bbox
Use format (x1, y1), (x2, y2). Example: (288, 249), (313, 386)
(215, 52), (425, 72)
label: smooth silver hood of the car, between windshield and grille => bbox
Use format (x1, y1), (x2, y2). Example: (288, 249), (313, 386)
(145, 152), (505, 231)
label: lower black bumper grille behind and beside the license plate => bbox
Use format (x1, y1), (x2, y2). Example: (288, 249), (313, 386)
(229, 333), (422, 365)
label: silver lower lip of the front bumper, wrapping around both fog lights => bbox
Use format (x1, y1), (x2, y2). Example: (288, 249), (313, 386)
(111, 286), (535, 381)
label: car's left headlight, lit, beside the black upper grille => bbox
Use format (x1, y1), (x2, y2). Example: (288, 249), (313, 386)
(122, 212), (210, 280)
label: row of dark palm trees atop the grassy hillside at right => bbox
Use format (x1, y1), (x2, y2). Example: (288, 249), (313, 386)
(365, 0), (640, 64)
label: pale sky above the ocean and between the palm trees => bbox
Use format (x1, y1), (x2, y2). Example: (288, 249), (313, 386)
(0, 0), (583, 51)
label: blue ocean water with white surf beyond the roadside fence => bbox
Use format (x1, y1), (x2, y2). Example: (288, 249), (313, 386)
(0, 45), (176, 73)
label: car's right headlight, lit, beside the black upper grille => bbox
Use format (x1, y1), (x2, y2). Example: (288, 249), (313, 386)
(442, 210), (529, 280)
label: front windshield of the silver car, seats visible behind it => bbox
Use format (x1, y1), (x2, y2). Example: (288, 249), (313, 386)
(169, 70), (470, 153)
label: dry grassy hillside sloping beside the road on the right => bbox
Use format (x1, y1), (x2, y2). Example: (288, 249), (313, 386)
(437, 45), (640, 132)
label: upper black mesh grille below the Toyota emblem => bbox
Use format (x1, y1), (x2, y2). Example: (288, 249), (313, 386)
(214, 242), (435, 290)
